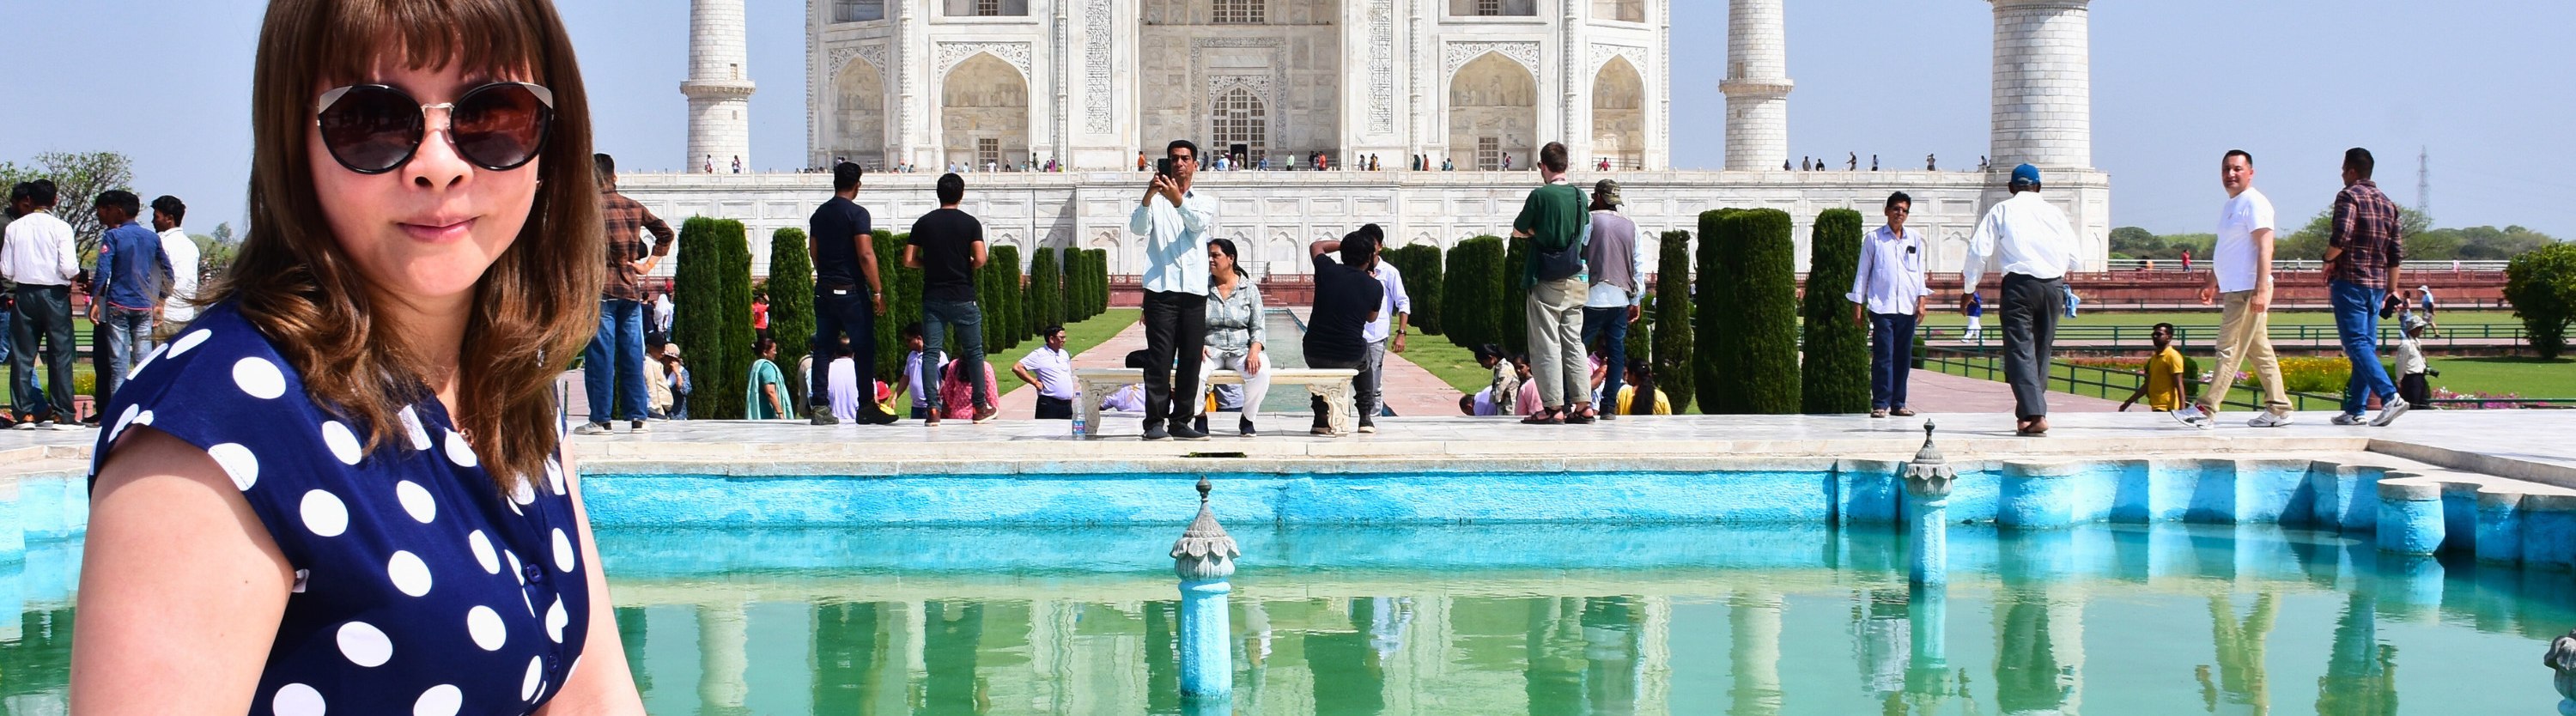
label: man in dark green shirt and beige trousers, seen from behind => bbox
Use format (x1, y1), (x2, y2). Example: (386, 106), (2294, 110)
(1512, 142), (1592, 425)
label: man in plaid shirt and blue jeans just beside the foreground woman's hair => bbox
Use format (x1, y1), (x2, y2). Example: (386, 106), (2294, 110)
(572, 155), (677, 435)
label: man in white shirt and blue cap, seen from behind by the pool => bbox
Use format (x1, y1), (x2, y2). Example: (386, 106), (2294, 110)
(1960, 165), (2076, 435)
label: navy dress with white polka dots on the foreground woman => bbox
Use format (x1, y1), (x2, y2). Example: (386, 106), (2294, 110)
(93, 304), (590, 716)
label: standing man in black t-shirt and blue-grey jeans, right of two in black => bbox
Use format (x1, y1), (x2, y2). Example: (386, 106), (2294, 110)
(904, 175), (999, 425)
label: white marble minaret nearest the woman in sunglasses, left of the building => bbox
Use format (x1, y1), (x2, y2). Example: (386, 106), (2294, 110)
(680, 0), (752, 173)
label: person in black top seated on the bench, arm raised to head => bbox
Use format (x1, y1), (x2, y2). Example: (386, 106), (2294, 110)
(1303, 224), (1386, 435)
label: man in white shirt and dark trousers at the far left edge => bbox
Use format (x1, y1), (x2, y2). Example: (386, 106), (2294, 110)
(0, 180), (80, 430)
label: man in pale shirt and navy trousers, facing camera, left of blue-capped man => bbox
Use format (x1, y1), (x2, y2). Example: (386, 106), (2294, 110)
(1844, 191), (1932, 417)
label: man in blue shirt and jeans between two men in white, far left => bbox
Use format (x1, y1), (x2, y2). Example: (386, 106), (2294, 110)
(90, 188), (170, 402)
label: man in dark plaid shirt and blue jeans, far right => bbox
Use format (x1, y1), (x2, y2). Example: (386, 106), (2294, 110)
(2326, 147), (2409, 425)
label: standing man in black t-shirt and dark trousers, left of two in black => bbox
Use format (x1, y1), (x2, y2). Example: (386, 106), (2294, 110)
(806, 162), (896, 425)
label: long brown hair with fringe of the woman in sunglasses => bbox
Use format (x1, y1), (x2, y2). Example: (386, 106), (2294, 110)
(216, 0), (605, 489)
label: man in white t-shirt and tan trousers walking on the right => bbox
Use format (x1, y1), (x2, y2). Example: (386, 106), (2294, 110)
(2174, 149), (2290, 428)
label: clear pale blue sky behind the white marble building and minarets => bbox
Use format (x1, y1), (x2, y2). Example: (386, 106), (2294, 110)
(0, 0), (2576, 237)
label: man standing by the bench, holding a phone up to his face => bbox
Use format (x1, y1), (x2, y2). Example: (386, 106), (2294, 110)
(1128, 139), (1216, 440)
